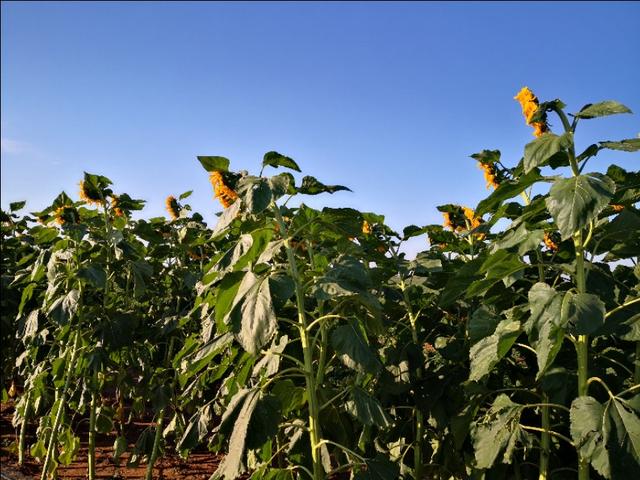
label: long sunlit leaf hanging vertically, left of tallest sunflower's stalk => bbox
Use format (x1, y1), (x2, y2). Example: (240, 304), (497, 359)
(525, 282), (566, 378)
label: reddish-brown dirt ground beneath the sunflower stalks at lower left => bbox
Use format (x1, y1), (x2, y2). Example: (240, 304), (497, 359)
(0, 402), (221, 480)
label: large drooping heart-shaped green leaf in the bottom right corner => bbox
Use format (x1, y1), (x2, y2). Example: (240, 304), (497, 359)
(570, 396), (640, 480)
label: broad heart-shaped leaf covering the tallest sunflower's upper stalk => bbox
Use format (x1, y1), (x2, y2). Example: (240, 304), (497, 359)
(546, 173), (615, 240)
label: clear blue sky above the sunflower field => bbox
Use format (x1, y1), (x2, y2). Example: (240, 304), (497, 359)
(1, 2), (640, 255)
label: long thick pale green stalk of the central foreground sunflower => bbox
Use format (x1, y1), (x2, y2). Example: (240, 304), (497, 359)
(272, 203), (324, 480)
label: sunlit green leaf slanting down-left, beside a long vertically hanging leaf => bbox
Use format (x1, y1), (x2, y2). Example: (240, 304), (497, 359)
(469, 319), (520, 381)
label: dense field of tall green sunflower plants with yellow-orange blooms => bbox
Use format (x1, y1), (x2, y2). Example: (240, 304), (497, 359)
(0, 88), (640, 480)
